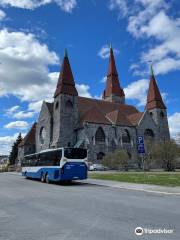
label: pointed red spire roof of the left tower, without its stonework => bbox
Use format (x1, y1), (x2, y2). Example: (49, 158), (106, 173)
(54, 49), (78, 97)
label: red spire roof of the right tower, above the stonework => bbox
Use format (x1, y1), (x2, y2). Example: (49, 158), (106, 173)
(146, 65), (166, 110)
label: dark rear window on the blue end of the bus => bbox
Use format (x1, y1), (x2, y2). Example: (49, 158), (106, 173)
(64, 148), (87, 159)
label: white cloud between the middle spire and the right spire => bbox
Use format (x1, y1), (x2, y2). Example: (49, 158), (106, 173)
(124, 79), (149, 106)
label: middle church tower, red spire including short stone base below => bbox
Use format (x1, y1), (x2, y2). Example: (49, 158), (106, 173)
(103, 47), (125, 104)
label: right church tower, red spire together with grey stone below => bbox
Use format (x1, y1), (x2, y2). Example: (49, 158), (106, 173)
(146, 66), (170, 140)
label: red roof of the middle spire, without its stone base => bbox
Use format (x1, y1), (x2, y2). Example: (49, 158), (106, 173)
(103, 47), (125, 98)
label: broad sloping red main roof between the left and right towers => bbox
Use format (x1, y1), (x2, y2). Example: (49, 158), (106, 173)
(78, 97), (140, 126)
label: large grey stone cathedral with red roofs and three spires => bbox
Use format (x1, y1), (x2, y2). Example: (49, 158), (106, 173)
(19, 47), (170, 165)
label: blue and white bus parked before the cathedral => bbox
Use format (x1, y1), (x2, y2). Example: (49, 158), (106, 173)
(22, 148), (87, 183)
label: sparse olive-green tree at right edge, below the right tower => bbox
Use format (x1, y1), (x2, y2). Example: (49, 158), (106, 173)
(152, 140), (180, 171)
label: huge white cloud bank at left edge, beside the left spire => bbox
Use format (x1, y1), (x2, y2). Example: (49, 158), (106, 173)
(0, 29), (59, 102)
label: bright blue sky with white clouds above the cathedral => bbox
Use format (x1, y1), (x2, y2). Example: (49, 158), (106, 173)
(0, 0), (180, 154)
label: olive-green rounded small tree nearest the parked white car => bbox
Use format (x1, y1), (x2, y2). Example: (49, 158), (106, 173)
(102, 150), (129, 171)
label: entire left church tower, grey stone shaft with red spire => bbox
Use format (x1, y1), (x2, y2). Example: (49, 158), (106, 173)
(52, 51), (78, 147)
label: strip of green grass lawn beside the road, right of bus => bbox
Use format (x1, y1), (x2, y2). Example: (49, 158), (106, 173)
(89, 172), (180, 187)
